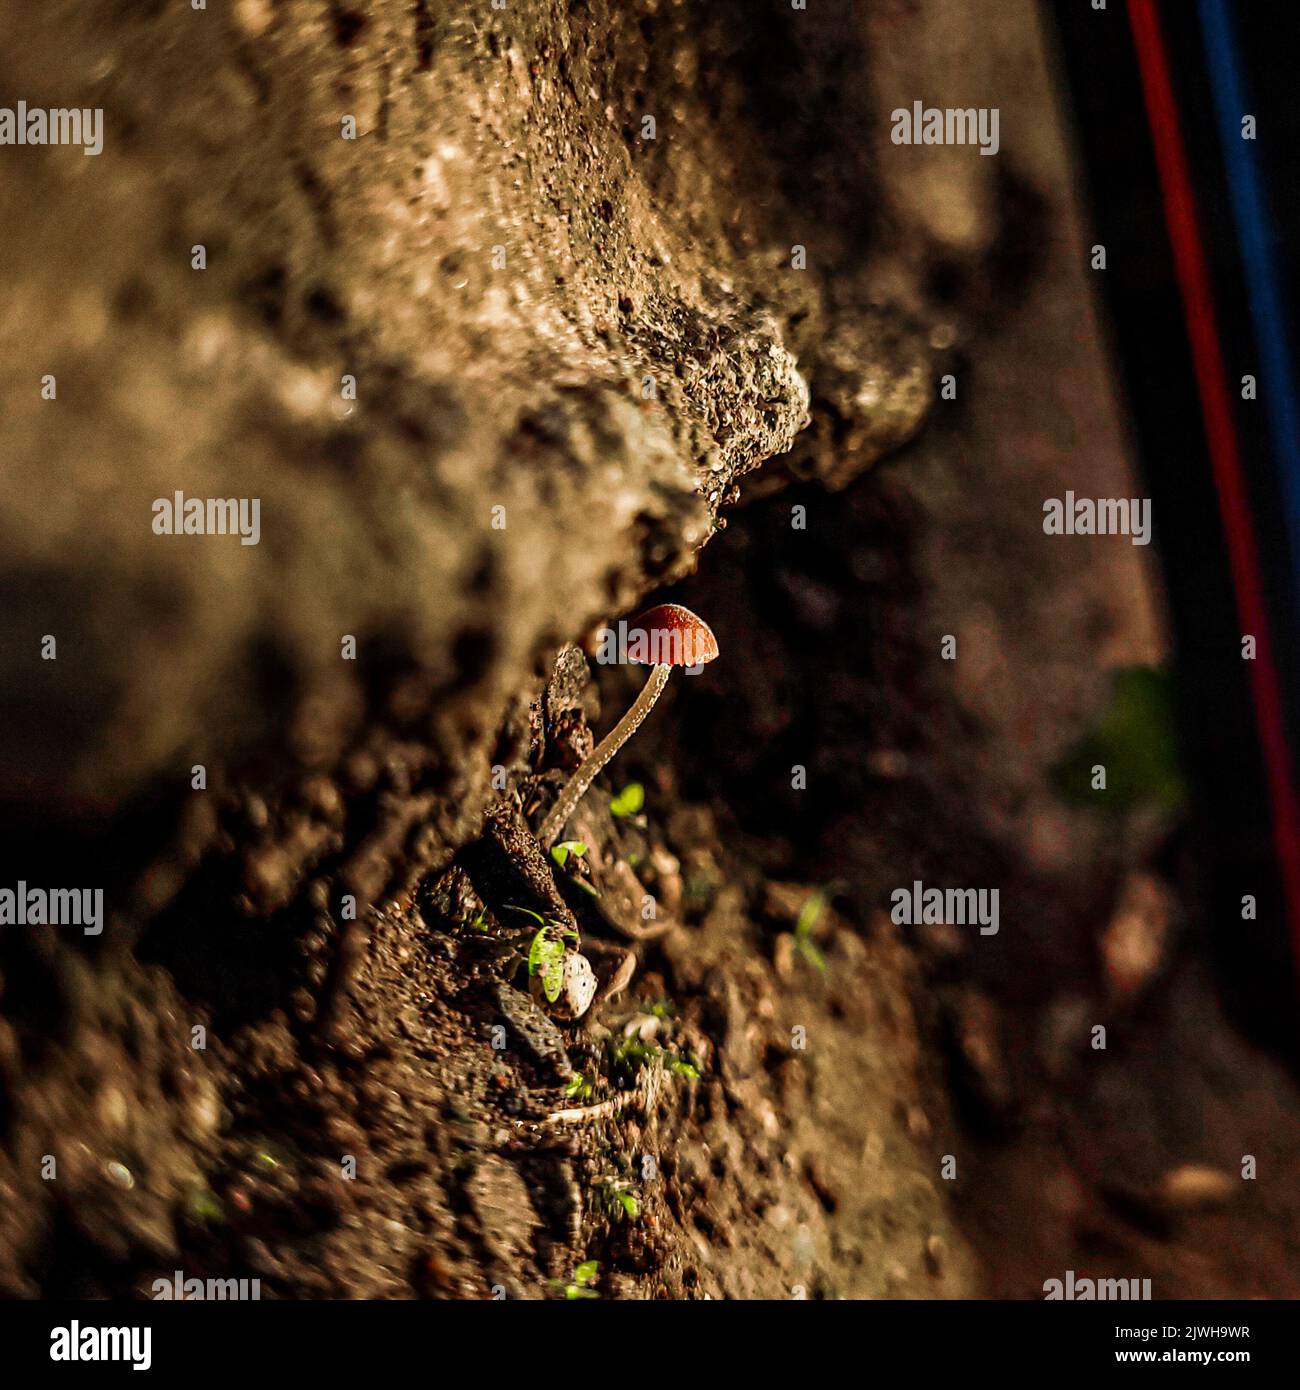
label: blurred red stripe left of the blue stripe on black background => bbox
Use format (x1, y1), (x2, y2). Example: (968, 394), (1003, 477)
(1129, 0), (1300, 976)
